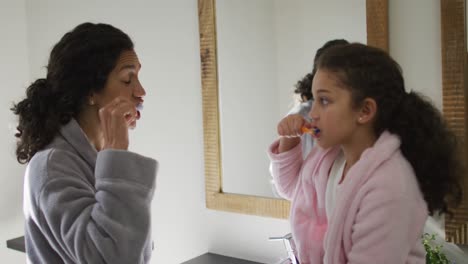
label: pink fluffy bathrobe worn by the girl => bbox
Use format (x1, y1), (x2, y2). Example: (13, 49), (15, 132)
(268, 132), (428, 264)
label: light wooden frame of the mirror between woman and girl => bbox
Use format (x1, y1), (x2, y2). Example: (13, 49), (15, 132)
(198, 0), (388, 219)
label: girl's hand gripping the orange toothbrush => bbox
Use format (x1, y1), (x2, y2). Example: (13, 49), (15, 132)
(277, 114), (310, 153)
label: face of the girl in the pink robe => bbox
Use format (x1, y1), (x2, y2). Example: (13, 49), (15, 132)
(309, 69), (359, 148)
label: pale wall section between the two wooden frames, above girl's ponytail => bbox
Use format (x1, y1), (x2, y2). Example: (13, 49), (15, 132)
(389, 0), (442, 110)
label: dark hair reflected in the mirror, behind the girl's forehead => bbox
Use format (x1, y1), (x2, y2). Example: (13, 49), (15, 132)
(294, 39), (349, 101)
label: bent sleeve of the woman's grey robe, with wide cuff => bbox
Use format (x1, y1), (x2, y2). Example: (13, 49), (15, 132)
(37, 150), (157, 264)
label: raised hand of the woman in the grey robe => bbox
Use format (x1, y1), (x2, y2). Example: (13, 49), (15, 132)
(99, 96), (138, 150)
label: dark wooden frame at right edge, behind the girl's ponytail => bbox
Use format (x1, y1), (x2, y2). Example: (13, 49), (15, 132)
(440, 0), (468, 245)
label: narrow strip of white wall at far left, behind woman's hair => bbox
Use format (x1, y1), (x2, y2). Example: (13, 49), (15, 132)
(0, 0), (29, 263)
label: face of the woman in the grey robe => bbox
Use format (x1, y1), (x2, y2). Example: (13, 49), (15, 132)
(93, 50), (146, 127)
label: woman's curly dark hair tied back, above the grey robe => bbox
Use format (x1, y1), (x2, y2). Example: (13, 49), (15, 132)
(11, 23), (133, 164)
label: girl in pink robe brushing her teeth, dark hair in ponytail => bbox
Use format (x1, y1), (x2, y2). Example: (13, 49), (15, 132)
(269, 44), (462, 264)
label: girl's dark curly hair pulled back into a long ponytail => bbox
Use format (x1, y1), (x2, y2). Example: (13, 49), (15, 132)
(317, 43), (465, 215)
